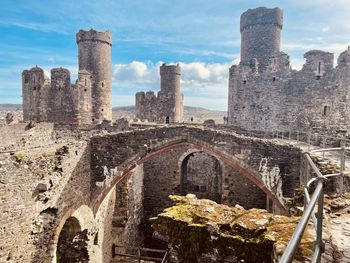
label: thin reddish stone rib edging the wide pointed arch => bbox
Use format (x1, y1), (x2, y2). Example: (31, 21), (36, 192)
(91, 141), (288, 214)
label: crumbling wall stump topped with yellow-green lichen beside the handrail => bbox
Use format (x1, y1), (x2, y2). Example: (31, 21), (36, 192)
(151, 194), (312, 263)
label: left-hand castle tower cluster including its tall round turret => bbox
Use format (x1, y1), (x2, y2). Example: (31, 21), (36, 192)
(22, 29), (112, 125)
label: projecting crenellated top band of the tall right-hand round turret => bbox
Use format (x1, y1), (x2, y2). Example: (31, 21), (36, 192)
(240, 7), (283, 32)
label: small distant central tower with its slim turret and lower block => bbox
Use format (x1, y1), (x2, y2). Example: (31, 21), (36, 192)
(135, 64), (183, 123)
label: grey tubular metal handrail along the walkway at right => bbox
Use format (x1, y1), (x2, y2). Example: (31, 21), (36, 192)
(280, 146), (350, 263)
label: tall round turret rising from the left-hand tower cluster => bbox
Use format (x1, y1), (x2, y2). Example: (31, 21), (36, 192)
(77, 29), (112, 123)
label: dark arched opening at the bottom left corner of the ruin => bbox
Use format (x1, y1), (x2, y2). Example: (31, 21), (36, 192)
(56, 217), (89, 263)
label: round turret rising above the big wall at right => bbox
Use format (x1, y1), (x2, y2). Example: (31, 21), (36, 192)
(240, 7), (283, 71)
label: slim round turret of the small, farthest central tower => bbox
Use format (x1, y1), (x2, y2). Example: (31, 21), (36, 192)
(158, 63), (183, 122)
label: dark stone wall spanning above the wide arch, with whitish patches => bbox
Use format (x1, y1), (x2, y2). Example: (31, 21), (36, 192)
(91, 126), (301, 213)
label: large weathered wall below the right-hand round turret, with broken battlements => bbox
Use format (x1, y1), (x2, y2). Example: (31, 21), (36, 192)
(229, 51), (350, 131)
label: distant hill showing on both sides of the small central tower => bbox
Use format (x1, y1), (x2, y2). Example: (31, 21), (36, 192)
(113, 106), (227, 123)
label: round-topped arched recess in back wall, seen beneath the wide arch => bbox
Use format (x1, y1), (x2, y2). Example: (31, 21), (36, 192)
(181, 152), (222, 203)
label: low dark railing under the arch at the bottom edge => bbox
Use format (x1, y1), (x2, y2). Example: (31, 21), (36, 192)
(112, 244), (169, 263)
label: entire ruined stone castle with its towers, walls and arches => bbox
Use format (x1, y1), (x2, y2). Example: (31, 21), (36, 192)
(0, 5), (350, 263)
